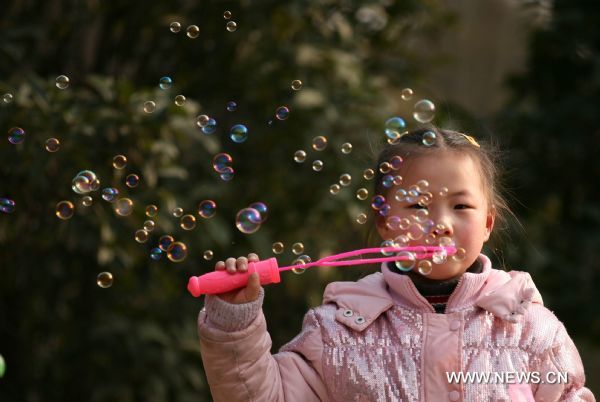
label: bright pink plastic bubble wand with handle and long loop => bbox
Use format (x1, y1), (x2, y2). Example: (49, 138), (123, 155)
(187, 246), (456, 297)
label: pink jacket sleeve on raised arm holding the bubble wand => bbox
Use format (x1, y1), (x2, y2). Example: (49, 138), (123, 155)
(198, 294), (328, 402)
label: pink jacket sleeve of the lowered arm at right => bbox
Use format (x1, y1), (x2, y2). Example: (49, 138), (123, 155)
(535, 323), (596, 402)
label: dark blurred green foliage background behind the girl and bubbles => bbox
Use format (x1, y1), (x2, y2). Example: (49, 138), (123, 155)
(0, 0), (600, 401)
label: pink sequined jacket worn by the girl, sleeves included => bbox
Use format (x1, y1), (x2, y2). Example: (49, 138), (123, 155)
(199, 255), (595, 402)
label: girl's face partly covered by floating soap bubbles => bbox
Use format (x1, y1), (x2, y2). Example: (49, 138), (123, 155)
(377, 151), (495, 280)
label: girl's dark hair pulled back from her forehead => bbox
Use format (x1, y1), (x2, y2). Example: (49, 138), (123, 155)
(374, 127), (518, 243)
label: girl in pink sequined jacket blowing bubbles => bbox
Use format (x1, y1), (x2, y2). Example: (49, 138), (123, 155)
(198, 129), (595, 402)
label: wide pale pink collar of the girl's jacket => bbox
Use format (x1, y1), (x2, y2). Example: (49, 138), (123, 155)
(323, 254), (543, 331)
